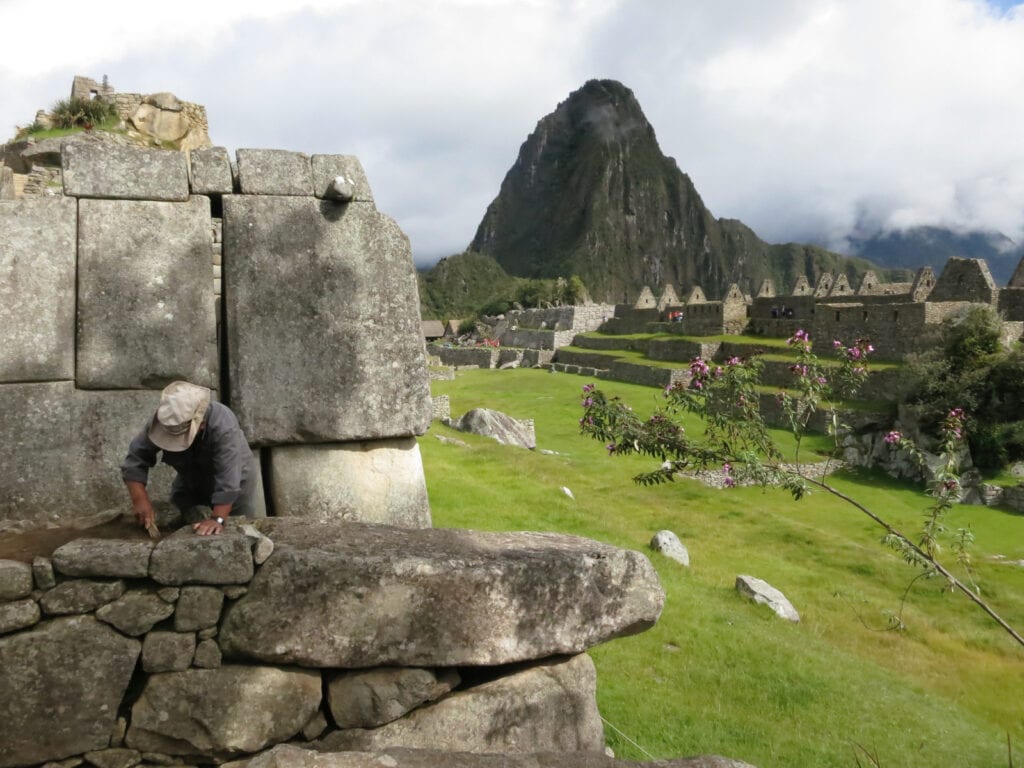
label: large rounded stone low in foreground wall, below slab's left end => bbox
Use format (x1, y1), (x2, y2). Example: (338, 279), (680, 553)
(126, 667), (322, 756)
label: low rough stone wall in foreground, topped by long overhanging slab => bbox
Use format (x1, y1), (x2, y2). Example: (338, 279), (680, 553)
(0, 518), (665, 768)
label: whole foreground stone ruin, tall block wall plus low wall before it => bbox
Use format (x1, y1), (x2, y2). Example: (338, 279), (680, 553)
(0, 141), (742, 768)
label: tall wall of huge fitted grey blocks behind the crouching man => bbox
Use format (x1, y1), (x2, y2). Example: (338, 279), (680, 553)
(0, 142), (430, 529)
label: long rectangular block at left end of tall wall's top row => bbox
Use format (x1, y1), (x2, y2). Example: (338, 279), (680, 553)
(61, 141), (188, 202)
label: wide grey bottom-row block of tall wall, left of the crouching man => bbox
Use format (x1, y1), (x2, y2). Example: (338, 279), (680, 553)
(0, 382), (174, 529)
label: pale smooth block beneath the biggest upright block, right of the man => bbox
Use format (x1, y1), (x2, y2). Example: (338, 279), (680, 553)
(267, 437), (431, 528)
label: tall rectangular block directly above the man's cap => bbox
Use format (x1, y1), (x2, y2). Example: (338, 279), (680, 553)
(77, 197), (218, 389)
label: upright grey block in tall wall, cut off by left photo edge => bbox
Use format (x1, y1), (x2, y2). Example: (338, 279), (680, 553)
(0, 198), (78, 382)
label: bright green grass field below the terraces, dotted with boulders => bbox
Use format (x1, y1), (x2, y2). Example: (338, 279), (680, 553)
(420, 370), (1024, 768)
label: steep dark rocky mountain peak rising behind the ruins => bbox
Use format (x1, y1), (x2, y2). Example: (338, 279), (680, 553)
(470, 80), (897, 302)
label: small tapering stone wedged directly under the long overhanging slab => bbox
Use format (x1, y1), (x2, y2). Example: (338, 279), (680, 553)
(327, 667), (460, 728)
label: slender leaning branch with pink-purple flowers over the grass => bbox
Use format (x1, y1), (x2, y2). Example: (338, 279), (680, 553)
(580, 331), (1024, 646)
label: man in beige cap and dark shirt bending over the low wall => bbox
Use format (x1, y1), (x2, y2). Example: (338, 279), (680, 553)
(121, 381), (259, 536)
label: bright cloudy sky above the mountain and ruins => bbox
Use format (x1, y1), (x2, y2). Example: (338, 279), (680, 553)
(0, 0), (1024, 265)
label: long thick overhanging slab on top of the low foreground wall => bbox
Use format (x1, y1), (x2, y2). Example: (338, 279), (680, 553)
(218, 517), (665, 669)
